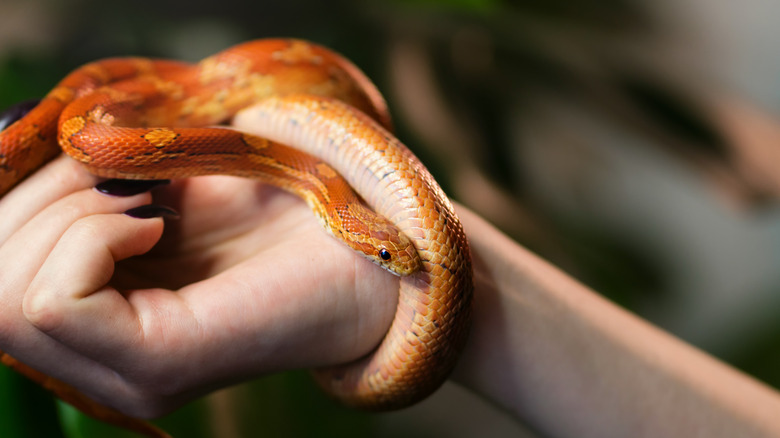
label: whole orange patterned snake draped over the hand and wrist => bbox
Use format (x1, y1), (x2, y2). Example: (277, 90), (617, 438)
(0, 39), (473, 436)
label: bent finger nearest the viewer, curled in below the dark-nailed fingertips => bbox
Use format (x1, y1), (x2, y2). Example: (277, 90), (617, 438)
(23, 209), (163, 362)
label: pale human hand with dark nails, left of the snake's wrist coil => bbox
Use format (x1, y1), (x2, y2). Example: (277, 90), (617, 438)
(0, 153), (398, 418)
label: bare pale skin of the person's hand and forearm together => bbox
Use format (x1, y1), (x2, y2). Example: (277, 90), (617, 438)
(0, 157), (780, 437)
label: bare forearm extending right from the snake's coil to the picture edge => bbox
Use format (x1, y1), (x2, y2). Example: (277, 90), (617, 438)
(454, 207), (780, 437)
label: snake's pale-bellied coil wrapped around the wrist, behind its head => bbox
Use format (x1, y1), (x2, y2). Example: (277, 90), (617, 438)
(234, 95), (472, 408)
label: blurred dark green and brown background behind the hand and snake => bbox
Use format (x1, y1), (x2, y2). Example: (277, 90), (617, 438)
(0, 0), (780, 438)
